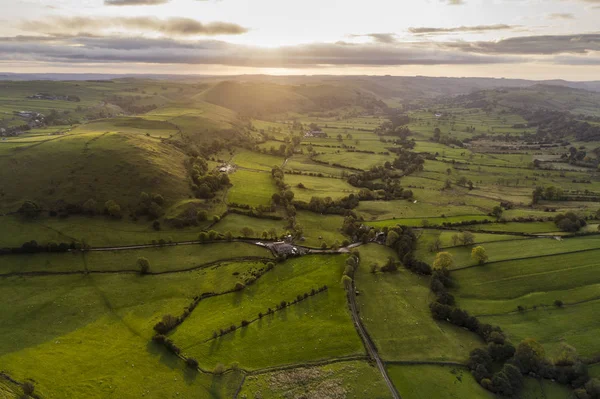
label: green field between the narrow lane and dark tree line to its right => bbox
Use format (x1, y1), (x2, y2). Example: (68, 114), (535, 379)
(356, 244), (482, 361)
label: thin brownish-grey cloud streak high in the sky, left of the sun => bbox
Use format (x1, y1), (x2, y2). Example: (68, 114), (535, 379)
(20, 17), (248, 36)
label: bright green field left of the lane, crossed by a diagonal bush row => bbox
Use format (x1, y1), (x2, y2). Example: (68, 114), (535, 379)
(171, 256), (364, 370)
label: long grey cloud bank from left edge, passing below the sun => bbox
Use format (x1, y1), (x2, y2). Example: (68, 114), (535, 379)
(0, 36), (518, 68)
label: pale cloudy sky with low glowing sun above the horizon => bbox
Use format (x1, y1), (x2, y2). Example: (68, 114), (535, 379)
(0, 0), (600, 81)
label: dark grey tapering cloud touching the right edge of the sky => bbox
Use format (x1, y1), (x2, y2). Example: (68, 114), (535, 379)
(440, 33), (600, 55)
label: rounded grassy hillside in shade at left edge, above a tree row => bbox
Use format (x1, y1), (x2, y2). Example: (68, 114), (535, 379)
(0, 130), (189, 211)
